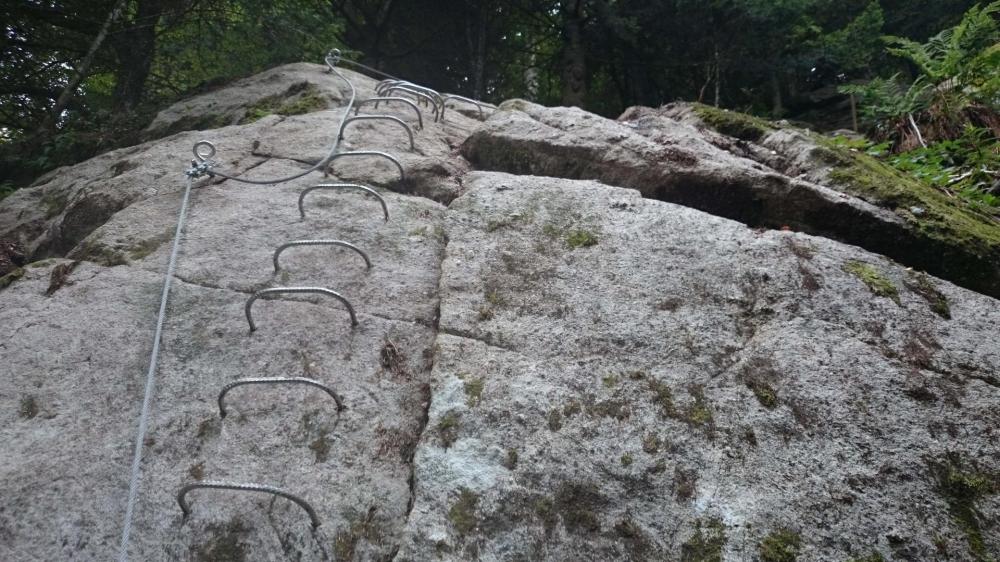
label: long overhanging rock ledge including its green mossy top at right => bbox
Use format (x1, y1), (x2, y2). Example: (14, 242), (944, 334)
(463, 100), (1000, 297)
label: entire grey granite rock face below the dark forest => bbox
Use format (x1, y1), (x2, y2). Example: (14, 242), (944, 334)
(0, 61), (1000, 562)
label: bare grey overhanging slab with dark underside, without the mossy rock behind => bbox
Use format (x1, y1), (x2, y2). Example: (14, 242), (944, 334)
(462, 100), (1000, 296)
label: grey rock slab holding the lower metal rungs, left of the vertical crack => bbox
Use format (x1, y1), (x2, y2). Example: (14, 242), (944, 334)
(0, 164), (443, 560)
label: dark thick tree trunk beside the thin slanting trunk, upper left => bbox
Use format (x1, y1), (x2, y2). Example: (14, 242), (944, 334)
(112, 0), (164, 112)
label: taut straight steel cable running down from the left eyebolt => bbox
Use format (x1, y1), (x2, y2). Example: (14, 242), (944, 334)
(118, 168), (203, 562)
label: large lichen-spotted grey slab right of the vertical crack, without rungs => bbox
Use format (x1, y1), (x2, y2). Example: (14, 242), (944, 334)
(398, 172), (1000, 561)
